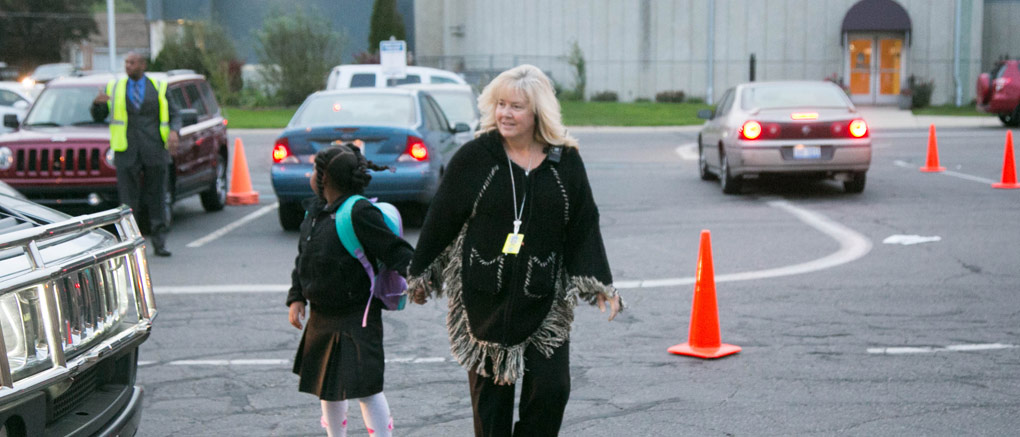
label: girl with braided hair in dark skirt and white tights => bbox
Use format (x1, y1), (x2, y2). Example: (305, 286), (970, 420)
(287, 144), (412, 437)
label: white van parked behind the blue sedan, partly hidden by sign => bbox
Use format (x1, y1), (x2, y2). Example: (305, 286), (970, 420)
(325, 63), (467, 90)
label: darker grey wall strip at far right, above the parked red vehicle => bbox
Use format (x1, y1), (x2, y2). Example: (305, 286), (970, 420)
(981, 0), (1020, 71)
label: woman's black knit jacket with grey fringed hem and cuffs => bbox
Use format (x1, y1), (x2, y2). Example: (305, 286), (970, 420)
(409, 130), (616, 383)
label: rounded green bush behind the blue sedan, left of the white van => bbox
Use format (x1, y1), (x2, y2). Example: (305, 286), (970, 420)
(255, 9), (345, 105)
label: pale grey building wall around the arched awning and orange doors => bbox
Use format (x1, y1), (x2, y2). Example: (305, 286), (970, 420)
(416, 0), (987, 104)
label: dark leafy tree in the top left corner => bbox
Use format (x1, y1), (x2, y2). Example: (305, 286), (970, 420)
(0, 0), (98, 71)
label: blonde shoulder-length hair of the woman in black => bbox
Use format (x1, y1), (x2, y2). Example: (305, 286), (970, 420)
(475, 64), (577, 148)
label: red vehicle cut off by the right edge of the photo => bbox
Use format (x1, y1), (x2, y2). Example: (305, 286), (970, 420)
(977, 60), (1020, 128)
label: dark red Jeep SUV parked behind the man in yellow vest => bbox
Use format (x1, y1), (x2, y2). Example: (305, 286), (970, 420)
(0, 70), (227, 211)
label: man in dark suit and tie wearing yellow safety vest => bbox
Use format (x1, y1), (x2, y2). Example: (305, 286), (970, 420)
(92, 52), (181, 256)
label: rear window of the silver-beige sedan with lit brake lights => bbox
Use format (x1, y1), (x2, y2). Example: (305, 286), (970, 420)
(741, 83), (847, 110)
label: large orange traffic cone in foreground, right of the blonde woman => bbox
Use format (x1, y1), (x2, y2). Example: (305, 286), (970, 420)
(667, 230), (741, 358)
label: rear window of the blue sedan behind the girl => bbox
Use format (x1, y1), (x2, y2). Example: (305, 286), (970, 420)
(290, 93), (415, 127)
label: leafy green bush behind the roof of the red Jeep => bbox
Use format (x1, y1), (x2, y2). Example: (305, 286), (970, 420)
(150, 21), (242, 103)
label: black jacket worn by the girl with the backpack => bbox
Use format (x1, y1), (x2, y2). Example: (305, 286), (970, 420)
(287, 196), (413, 315)
